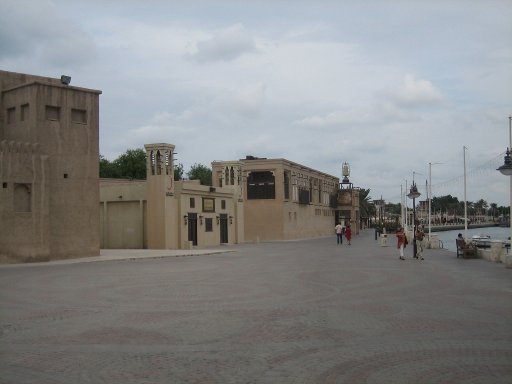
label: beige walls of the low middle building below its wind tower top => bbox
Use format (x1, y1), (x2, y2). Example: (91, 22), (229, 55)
(100, 171), (240, 249)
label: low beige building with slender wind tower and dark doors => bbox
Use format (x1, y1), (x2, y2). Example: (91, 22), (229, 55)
(100, 143), (244, 249)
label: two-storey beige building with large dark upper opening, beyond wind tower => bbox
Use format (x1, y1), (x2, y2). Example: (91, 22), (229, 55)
(212, 156), (339, 242)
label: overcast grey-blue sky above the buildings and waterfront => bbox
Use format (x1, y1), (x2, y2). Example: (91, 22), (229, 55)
(0, 0), (512, 206)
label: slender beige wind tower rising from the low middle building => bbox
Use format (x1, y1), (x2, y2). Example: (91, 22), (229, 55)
(144, 143), (178, 249)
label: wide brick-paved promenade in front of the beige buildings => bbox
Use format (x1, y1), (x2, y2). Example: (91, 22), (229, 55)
(0, 231), (512, 384)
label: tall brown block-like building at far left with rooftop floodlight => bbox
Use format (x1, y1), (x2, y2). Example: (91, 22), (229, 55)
(0, 71), (101, 261)
